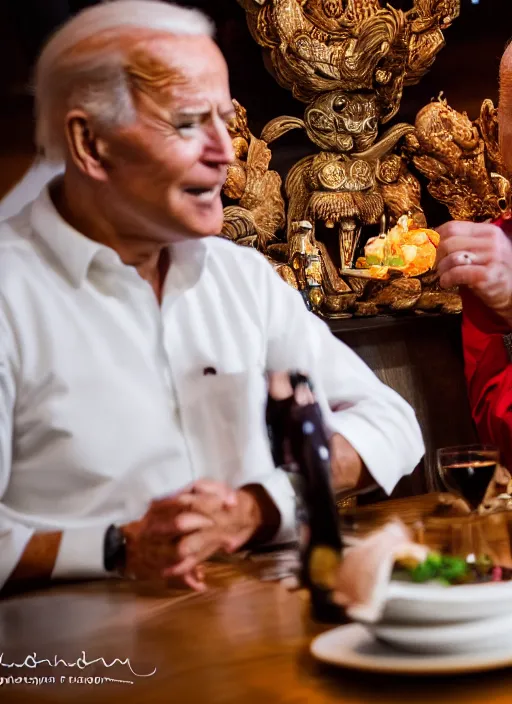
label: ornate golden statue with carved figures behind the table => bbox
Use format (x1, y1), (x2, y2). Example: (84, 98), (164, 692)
(224, 0), (510, 317)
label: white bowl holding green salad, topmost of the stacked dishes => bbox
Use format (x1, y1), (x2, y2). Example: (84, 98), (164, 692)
(382, 582), (512, 624)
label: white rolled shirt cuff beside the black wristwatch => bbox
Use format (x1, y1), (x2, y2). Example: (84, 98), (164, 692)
(52, 525), (112, 579)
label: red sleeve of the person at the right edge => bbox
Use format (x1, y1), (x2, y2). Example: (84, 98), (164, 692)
(462, 290), (512, 471)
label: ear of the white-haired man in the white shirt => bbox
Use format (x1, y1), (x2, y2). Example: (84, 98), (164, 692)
(66, 110), (108, 181)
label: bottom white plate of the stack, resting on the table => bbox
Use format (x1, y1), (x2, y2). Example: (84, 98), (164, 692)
(311, 624), (512, 675)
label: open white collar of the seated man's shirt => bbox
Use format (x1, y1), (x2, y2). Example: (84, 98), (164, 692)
(31, 180), (209, 287)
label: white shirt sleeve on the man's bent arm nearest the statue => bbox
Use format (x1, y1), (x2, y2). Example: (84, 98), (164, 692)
(267, 267), (425, 494)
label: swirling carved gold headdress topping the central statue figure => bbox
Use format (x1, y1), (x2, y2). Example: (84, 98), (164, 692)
(239, 0), (460, 123)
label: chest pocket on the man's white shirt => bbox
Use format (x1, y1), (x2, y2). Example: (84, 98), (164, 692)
(179, 367), (274, 487)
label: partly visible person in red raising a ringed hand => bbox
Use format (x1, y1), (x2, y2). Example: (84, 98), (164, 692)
(438, 45), (512, 471)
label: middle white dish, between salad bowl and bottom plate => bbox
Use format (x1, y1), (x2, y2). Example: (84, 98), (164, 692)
(369, 613), (512, 655)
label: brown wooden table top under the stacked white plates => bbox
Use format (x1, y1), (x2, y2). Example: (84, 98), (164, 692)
(0, 565), (512, 704)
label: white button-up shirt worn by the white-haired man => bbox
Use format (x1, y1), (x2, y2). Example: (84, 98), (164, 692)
(0, 189), (424, 586)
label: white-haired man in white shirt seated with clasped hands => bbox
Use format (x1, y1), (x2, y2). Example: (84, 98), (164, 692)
(0, 0), (423, 589)
